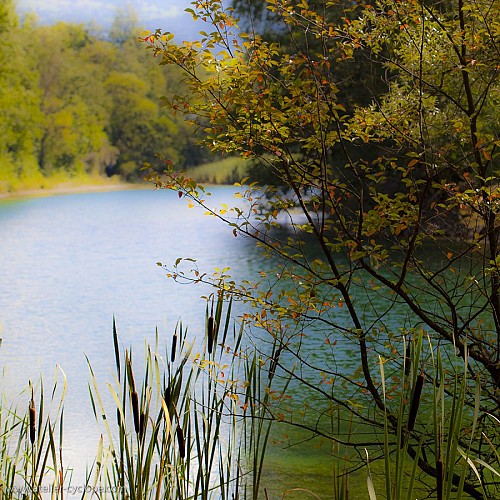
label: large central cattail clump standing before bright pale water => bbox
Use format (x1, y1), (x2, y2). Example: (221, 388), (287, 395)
(85, 295), (274, 500)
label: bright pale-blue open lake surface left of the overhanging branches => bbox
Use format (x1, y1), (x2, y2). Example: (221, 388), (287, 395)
(0, 187), (262, 484)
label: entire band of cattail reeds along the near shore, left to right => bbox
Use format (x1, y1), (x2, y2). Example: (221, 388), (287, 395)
(0, 300), (500, 500)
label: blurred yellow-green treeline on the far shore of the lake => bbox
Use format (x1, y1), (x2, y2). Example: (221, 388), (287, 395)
(0, 0), (204, 192)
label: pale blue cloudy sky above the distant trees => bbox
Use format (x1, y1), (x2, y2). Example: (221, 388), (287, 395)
(16, 0), (200, 39)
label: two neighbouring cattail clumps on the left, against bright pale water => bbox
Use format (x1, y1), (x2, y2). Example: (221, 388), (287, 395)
(0, 295), (280, 500)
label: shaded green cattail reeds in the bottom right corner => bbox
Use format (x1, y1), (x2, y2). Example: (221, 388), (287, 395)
(367, 334), (500, 500)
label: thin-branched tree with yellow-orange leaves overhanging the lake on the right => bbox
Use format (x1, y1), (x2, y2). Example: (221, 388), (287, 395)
(144, 0), (500, 498)
